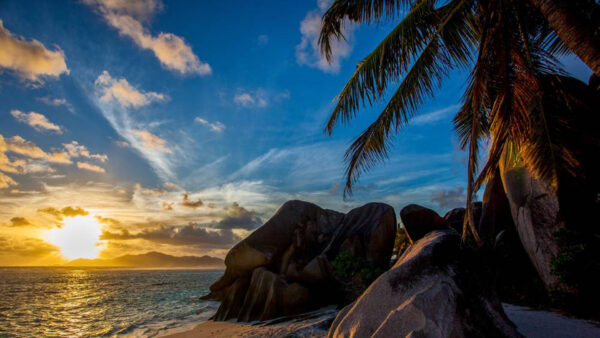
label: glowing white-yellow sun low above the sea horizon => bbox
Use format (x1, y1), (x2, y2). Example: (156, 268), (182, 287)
(47, 216), (102, 259)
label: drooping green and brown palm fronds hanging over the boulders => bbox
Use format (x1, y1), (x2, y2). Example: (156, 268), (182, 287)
(319, 0), (592, 244)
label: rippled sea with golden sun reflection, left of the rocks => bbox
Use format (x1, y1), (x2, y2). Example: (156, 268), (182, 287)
(0, 267), (223, 337)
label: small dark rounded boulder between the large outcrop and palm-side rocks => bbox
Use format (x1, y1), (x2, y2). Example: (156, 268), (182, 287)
(400, 204), (448, 243)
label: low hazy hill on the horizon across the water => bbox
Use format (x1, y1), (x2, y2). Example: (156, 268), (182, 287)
(65, 252), (225, 269)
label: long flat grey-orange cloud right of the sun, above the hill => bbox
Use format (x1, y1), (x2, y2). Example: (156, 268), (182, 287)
(100, 224), (241, 247)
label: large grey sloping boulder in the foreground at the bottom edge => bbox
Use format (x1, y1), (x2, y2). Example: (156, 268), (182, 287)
(329, 229), (520, 337)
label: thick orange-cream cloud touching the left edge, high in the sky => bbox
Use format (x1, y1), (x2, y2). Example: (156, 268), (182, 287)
(0, 20), (69, 83)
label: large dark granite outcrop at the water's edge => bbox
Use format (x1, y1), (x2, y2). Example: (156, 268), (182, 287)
(208, 201), (397, 321)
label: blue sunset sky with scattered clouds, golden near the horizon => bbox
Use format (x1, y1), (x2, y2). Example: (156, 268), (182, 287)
(0, 0), (590, 265)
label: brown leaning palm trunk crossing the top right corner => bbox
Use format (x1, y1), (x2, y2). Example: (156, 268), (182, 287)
(531, 0), (600, 75)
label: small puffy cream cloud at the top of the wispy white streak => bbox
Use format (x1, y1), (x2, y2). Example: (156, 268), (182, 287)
(94, 70), (168, 108)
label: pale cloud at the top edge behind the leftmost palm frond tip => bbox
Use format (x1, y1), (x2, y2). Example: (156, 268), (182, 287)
(296, 0), (354, 73)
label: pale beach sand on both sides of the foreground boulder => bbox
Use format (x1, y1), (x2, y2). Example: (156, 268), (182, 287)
(164, 304), (600, 338)
